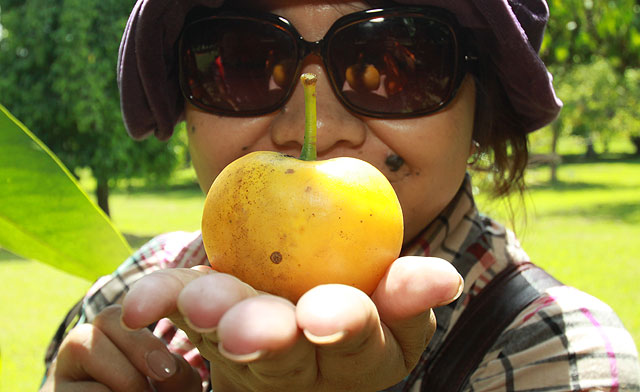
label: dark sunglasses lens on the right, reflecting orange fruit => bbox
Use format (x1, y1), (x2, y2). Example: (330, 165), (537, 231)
(328, 16), (458, 116)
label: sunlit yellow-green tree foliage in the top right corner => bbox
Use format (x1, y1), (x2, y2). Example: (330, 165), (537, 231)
(541, 0), (640, 162)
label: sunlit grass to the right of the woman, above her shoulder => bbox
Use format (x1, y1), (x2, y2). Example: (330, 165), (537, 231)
(478, 160), (640, 352)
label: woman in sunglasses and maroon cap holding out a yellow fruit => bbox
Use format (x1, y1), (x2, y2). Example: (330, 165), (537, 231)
(42, 0), (640, 391)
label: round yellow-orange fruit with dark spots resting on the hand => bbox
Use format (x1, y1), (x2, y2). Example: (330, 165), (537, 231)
(202, 73), (403, 302)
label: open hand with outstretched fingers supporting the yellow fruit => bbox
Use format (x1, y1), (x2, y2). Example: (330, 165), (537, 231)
(122, 257), (462, 392)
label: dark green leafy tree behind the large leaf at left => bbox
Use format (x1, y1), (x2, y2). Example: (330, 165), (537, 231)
(0, 0), (177, 213)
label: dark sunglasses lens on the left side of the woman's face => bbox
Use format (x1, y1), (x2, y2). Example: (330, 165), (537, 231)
(180, 17), (296, 115)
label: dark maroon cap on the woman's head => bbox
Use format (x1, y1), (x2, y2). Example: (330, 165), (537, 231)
(118, 0), (562, 140)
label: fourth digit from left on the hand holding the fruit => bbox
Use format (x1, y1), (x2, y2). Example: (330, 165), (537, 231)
(297, 285), (407, 390)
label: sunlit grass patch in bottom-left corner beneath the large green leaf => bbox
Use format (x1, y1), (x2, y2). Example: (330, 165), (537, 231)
(0, 258), (90, 392)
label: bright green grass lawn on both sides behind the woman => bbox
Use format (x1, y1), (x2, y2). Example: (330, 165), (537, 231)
(0, 159), (640, 392)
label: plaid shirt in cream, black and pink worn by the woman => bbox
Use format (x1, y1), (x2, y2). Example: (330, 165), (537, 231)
(46, 178), (640, 392)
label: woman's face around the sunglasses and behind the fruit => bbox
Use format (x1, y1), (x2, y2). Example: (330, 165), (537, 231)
(185, 0), (475, 242)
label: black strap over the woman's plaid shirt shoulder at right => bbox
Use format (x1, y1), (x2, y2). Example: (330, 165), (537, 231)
(421, 263), (562, 392)
